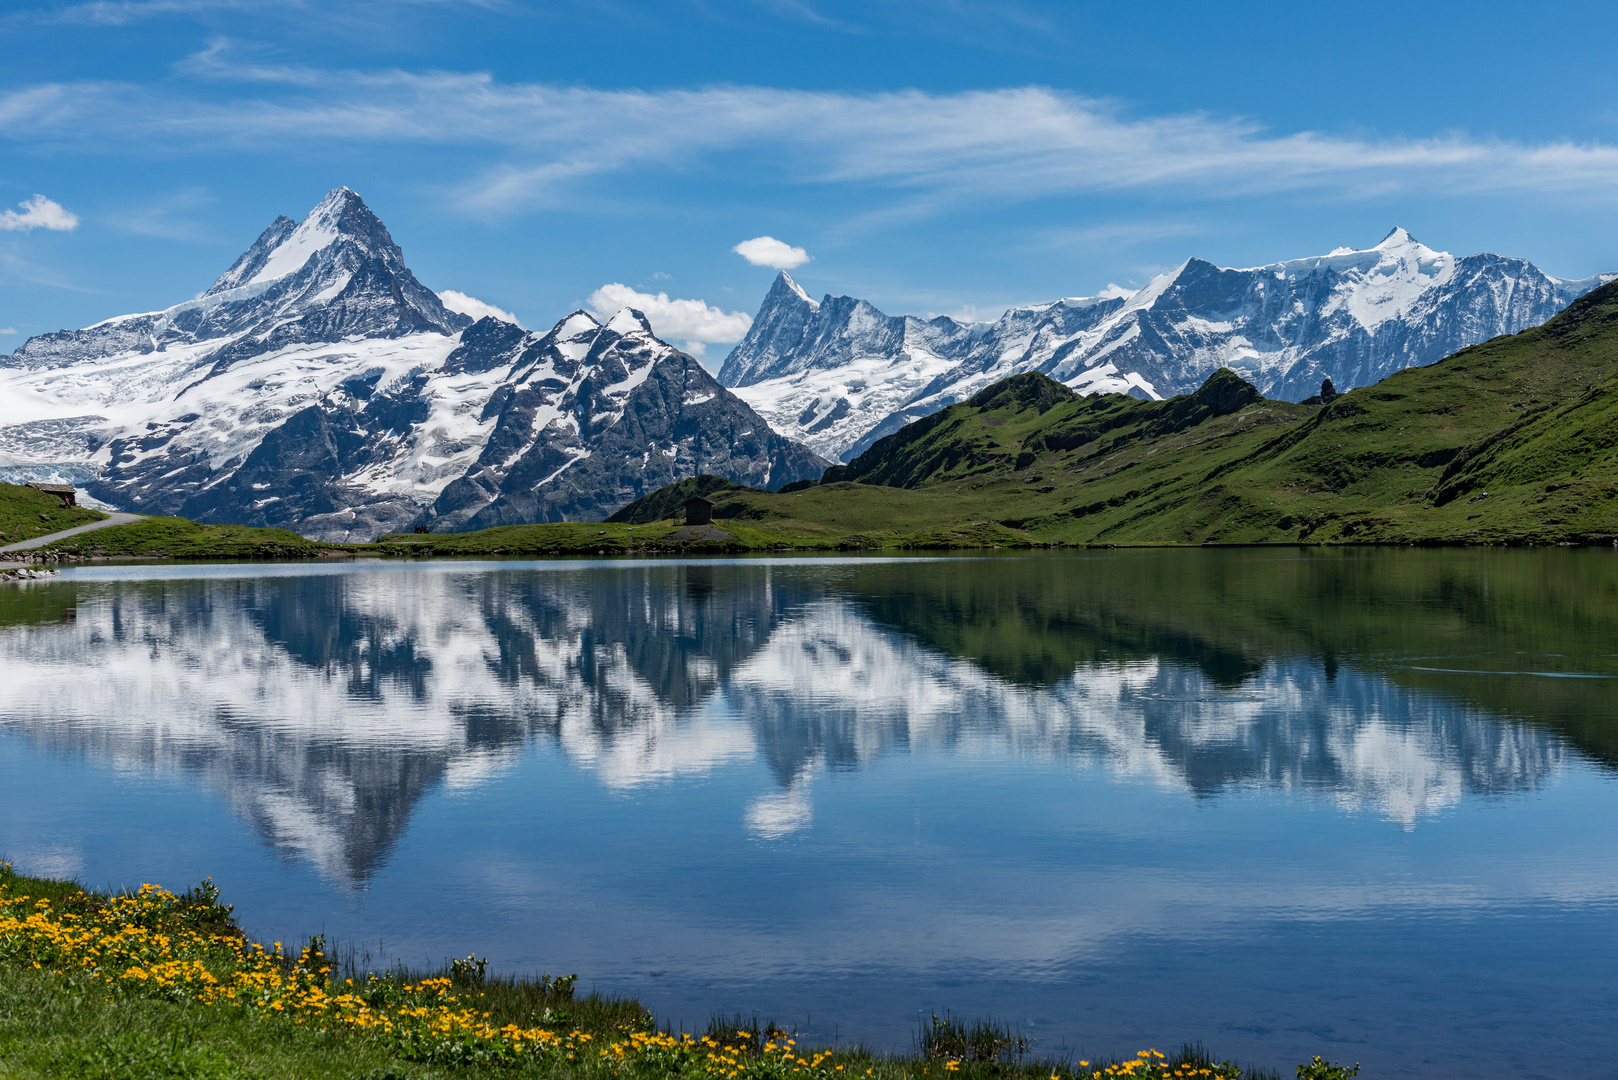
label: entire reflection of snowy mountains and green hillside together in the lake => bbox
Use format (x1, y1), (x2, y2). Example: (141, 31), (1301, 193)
(0, 552), (1618, 882)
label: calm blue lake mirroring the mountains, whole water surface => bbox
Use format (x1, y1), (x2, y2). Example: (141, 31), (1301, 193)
(0, 549), (1618, 1077)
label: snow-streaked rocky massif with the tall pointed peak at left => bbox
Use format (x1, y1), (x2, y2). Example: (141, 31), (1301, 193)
(0, 188), (825, 541)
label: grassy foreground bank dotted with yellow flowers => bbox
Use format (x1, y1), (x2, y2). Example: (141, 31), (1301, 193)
(0, 865), (1354, 1080)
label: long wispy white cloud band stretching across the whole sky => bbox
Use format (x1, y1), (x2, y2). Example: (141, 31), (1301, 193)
(0, 60), (1618, 214)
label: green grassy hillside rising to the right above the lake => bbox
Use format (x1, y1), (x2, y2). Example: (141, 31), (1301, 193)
(601, 283), (1618, 546)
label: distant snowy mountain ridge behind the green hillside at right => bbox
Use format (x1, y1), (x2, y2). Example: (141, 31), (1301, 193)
(720, 228), (1618, 461)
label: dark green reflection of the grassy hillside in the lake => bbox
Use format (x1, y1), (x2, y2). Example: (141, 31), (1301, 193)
(854, 549), (1618, 764)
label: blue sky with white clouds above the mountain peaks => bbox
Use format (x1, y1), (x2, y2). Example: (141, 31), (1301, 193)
(0, 0), (1618, 363)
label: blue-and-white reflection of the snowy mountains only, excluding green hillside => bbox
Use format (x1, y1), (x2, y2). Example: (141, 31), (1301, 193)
(0, 563), (1566, 881)
